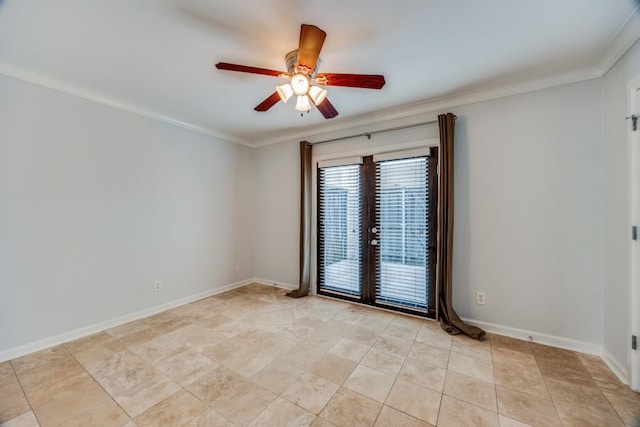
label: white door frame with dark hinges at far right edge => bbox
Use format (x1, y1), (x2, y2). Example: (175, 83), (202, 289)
(627, 75), (640, 391)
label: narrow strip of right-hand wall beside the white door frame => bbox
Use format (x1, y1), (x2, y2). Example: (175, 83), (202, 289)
(602, 39), (640, 373)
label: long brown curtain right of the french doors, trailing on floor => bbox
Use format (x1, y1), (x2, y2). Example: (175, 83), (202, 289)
(436, 113), (485, 340)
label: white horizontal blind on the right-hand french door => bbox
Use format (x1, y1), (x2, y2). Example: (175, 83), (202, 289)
(376, 157), (432, 311)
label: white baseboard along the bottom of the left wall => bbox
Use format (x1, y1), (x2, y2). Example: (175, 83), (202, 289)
(0, 278), (266, 362)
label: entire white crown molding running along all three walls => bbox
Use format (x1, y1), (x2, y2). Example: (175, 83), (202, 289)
(0, 6), (640, 148)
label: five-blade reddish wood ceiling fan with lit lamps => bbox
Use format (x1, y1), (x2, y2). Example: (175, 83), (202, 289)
(216, 24), (385, 119)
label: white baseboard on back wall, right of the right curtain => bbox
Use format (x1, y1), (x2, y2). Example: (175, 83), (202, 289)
(462, 318), (602, 356)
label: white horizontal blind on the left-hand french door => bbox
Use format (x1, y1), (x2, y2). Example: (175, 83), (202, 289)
(318, 164), (362, 296)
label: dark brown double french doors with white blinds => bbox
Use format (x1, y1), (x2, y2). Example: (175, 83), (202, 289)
(317, 148), (438, 317)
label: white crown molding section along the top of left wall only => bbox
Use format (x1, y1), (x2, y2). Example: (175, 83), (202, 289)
(0, 61), (252, 147)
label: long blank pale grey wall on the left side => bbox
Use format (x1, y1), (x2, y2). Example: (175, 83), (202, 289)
(0, 76), (254, 354)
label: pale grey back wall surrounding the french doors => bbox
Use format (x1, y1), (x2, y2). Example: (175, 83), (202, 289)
(256, 80), (603, 347)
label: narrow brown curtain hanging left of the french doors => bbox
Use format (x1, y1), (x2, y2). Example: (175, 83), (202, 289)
(287, 141), (311, 298)
